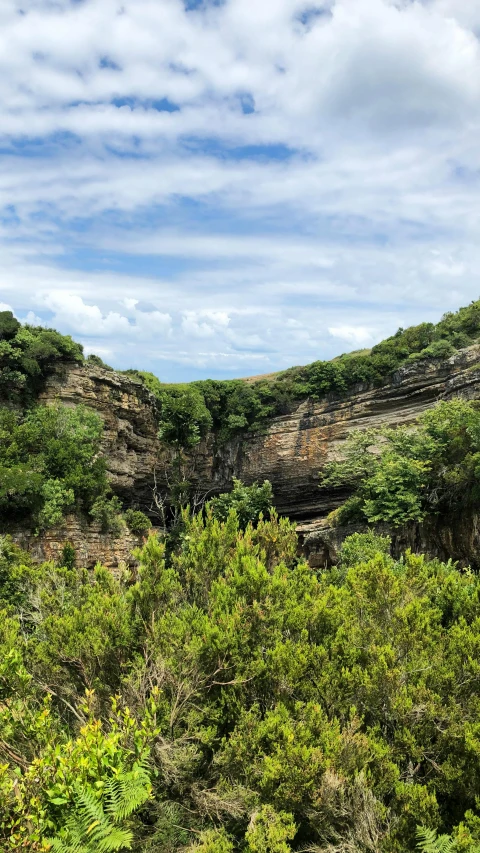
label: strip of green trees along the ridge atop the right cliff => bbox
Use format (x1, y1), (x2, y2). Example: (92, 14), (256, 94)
(127, 300), (480, 448)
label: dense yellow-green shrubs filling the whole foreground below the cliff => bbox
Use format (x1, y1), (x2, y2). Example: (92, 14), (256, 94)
(0, 502), (480, 853)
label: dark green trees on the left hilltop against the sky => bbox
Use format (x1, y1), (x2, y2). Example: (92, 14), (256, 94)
(0, 311), (83, 404)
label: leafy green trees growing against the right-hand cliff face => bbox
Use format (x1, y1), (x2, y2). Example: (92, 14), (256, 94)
(322, 399), (480, 526)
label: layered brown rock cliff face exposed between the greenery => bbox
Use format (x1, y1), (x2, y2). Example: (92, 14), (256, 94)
(34, 345), (480, 562)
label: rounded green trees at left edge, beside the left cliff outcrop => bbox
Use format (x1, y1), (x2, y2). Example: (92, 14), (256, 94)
(0, 405), (108, 527)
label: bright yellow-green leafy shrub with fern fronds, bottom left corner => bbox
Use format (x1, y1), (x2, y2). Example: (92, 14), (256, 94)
(0, 692), (155, 853)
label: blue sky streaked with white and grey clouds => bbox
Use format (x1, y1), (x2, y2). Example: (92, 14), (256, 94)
(0, 0), (480, 381)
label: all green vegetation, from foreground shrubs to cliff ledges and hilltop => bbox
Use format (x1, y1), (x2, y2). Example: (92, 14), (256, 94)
(0, 303), (480, 853)
